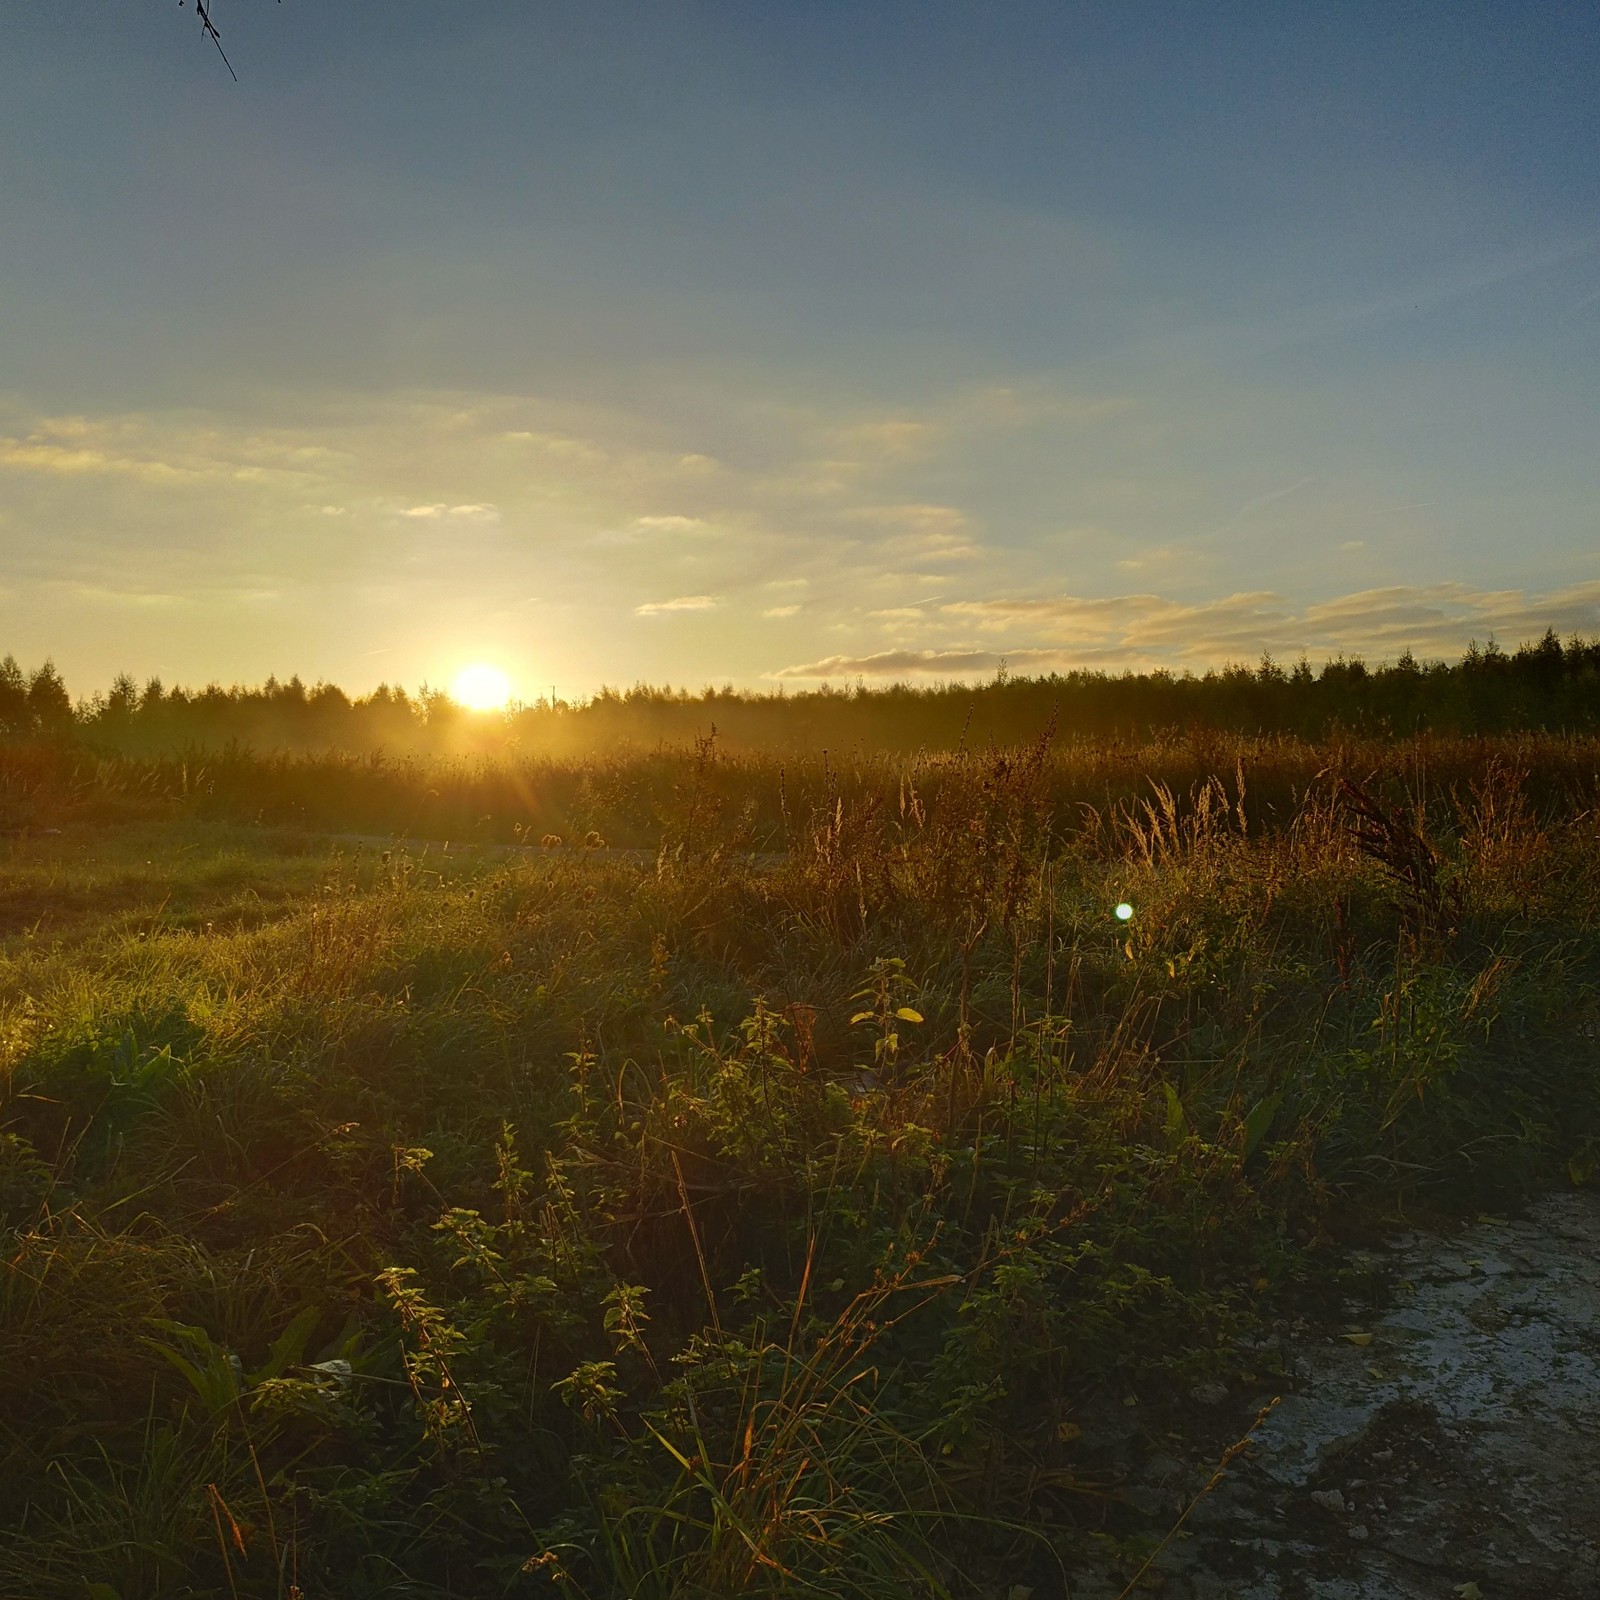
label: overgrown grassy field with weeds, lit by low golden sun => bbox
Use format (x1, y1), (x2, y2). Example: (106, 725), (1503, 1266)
(0, 736), (1600, 1600)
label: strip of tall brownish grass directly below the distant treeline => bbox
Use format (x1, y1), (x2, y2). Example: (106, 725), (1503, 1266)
(9, 725), (1600, 851)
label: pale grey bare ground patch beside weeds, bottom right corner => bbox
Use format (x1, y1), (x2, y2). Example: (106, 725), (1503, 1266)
(1132, 1194), (1600, 1600)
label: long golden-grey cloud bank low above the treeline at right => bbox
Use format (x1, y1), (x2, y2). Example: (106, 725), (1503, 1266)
(776, 579), (1600, 678)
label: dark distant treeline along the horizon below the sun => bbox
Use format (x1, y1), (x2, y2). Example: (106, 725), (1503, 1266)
(0, 632), (1600, 755)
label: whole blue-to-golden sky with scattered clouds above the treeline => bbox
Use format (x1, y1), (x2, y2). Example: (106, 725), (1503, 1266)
(0, 0), (1600, 699)
